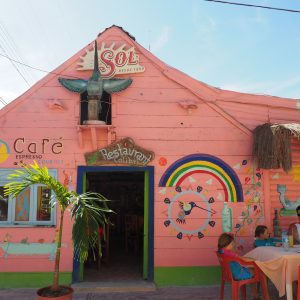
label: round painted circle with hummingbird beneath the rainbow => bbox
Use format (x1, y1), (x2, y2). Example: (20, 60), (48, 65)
(164, 186), (216, 240)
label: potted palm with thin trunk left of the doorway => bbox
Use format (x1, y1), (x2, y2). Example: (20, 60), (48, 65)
(5, 162), (112, 300)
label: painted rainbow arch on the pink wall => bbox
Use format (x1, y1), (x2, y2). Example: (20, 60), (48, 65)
(159, 154), (244, 202)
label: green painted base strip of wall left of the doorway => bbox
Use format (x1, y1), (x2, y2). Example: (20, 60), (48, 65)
(0, 272), (72, 289)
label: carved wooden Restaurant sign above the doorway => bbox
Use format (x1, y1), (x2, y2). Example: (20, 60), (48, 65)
(99, 144), (152, 165)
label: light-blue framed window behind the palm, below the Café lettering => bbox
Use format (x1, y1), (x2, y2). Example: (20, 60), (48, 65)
(0, 169), (57, 226)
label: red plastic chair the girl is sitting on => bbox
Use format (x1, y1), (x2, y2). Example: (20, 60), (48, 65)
(216, 251), (270, 300)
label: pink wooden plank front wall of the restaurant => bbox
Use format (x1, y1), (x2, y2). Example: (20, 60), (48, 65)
(0, 27), (299, 271)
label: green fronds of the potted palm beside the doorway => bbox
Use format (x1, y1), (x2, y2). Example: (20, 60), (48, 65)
(4, 162), (112, 261)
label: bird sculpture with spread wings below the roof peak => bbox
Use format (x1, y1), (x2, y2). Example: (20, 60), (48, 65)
(58, 41), (132, 120)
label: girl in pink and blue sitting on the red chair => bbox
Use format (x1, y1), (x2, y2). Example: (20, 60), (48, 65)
(218, 233), (258, 298)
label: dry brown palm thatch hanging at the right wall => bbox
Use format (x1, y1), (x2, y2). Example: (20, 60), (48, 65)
(253, 123), (300, 172)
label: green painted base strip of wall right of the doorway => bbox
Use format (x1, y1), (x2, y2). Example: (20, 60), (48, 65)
(154, 266), (221, 287)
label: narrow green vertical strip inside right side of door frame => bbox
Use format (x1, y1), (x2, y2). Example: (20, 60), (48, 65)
(143, 171), (149, 279)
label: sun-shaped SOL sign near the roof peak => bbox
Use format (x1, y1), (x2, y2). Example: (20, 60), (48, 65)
(77, 43), (145, 78)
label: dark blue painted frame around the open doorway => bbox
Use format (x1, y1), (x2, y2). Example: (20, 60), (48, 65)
(72, 166), (154, 283)
